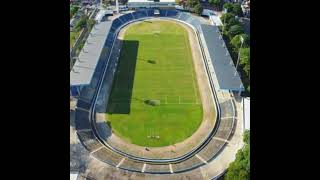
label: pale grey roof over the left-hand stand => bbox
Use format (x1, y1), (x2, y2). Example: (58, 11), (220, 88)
(70, 21), (112, 86)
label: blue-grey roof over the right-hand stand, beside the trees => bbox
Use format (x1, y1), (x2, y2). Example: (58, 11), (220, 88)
(201, 24), (244, 91)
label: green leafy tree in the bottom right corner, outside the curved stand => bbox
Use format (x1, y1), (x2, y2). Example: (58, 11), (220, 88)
(225, 130), (250, 180)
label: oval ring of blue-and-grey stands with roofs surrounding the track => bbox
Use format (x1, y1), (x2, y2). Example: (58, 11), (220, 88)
(70, 9), (243, 174)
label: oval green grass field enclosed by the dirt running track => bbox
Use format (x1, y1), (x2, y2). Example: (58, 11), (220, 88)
(107, 21), (202, 147)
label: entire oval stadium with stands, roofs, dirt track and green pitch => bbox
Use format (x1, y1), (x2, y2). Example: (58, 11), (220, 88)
(70, 9), (244, 179)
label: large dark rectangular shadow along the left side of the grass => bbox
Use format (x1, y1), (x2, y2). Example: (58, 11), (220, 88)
(107, 40), (139, 114)
